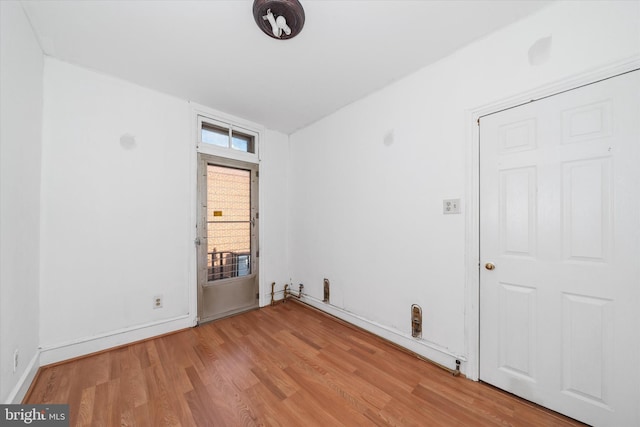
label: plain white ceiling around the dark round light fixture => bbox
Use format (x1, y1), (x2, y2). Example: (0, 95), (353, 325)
(18, 0), (551, 134)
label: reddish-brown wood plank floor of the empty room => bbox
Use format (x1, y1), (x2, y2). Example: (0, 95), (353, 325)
(24, 302), (581, 427)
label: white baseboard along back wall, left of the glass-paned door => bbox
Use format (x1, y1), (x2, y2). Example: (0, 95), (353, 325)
(40, 314), (195, 366)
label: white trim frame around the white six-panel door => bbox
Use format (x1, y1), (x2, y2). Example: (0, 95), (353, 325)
(465, 55), (640, 381)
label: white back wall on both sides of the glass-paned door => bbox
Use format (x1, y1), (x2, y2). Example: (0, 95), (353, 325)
(40, 58), (288, 364)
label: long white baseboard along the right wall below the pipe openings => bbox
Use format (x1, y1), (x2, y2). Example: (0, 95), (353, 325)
(300, 295), (467, 374)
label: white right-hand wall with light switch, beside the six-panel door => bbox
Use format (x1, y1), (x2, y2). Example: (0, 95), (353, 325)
(290, 2), (640, 369)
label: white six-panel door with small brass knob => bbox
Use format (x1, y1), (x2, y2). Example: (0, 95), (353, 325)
(480, 71), (640, 427)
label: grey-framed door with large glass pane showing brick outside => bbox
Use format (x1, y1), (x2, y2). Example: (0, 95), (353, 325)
(196, 154), (258, 323)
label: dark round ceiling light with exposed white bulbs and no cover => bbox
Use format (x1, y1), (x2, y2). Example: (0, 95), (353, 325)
(253, 0), (304, 40)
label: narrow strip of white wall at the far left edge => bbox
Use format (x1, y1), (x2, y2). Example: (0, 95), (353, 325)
(0, 1), (43, 403)
